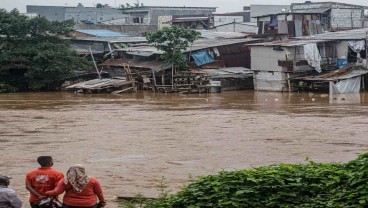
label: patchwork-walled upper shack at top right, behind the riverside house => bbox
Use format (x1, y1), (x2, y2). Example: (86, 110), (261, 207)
(255, 1), (368, 40)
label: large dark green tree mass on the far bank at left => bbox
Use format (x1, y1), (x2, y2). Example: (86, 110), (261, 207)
(0, 9), (91, 91)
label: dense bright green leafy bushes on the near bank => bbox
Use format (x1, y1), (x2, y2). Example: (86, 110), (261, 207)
(145, 153), (368, 208)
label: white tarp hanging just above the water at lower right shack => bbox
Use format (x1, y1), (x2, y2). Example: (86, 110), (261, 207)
(330, 76), (361, 94)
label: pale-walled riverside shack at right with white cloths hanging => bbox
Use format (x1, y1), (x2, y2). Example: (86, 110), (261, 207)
(249, 28), (368, 93)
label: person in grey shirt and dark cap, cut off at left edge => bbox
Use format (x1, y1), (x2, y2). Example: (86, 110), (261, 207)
(0, 175), (22, 208)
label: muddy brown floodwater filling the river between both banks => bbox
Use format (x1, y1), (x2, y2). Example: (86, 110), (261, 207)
(0, 91), (368, 207)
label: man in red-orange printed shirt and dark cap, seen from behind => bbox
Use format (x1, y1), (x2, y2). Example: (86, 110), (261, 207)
(26, 156), (64, 208)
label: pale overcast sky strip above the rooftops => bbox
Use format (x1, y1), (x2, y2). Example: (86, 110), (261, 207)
(0, 0), (368, 12)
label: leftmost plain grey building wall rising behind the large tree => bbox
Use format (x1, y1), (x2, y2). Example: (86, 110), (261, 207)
(27, 5), (66, 21)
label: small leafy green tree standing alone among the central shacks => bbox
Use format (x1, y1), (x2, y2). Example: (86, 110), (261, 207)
(147, 26), (201, 87)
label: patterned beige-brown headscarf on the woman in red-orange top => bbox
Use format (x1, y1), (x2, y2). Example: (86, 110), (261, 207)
(64, 164), (89, 193)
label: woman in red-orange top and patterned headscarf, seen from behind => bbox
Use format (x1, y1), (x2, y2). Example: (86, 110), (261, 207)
(46, 164), (106, 208)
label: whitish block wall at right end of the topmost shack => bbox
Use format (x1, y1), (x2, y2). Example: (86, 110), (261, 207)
(331, 9), (363, 29)
